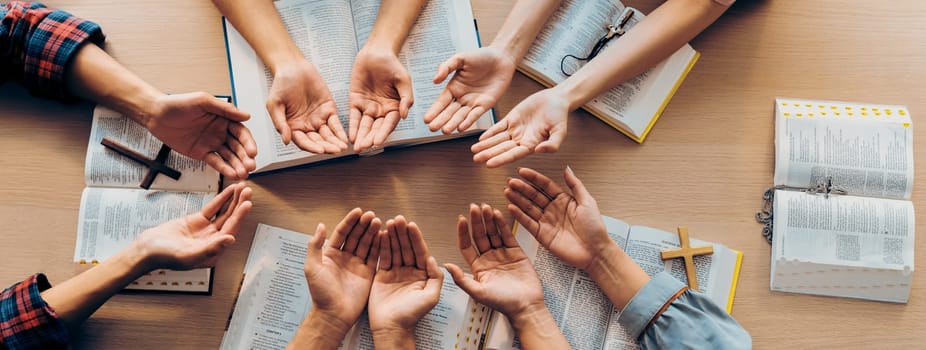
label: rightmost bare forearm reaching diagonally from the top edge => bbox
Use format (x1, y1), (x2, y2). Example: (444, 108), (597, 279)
(556, 0), (727, 110)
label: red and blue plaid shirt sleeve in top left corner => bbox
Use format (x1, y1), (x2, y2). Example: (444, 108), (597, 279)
(0, 1), (105, 99)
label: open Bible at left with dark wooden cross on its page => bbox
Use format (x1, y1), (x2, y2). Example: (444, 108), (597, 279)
(74, 106), (221, 294)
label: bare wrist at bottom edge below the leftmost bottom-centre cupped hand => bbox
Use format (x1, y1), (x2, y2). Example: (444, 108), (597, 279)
(286, 310), (352, 350)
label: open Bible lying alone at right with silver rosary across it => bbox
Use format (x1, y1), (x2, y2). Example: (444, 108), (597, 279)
(770, 98), (916, 303)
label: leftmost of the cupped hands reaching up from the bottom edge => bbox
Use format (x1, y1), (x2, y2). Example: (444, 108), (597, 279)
(305, 208), (382, 331)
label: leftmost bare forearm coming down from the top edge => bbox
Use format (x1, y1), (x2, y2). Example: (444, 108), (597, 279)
(212, 0), (305, 74)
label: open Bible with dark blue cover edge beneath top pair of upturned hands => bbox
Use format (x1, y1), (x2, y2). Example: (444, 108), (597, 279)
(224, 0), (495, 173)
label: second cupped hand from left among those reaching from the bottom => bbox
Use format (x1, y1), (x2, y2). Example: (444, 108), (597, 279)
(368, 215), (444, 336)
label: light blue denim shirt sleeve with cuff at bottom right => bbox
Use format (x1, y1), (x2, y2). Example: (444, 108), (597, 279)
(618, 272), (752, 349)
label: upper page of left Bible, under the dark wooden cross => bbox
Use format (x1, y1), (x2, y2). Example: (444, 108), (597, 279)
(84, 106), (220, 193)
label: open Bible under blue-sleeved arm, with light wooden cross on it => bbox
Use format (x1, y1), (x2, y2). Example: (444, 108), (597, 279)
(486, 216), (743, 350)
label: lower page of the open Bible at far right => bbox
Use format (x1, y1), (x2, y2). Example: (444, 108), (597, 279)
(773, 191), (916, 270)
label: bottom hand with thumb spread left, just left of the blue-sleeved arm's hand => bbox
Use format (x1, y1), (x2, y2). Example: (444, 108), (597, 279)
(444, 204), (546, 319)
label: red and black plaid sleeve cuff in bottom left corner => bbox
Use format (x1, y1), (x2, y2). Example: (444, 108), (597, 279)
(0, 274), (69, 350)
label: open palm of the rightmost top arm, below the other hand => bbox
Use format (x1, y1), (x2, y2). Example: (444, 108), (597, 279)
(471, 89), (569, 168)
